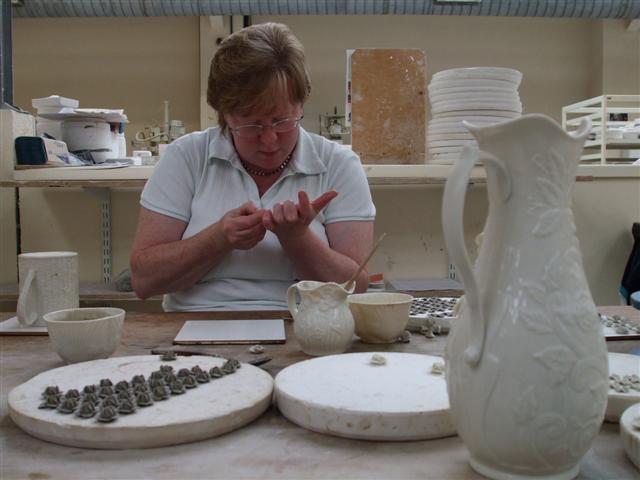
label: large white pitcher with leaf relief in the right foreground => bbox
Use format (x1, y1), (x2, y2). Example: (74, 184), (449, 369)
(443, 115), (608, 480)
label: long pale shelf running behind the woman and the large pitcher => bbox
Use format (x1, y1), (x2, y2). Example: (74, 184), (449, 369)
(0, 163), (640, 188)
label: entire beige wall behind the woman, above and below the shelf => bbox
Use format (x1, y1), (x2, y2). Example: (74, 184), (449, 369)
(3, 16), (640, 303)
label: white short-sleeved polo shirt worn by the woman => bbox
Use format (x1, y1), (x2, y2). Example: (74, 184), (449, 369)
(140, 128), (376, 311)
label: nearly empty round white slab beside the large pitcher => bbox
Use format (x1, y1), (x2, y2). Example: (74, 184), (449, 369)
(275, 352), (456, 441)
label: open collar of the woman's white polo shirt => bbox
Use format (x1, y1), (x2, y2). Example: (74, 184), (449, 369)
(208, 127), (327, 175)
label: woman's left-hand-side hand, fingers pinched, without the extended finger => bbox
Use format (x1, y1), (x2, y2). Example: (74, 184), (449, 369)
(220, 202), (267, 250)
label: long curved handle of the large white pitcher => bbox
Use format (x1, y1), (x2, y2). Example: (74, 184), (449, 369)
(442, 147), (511, 367)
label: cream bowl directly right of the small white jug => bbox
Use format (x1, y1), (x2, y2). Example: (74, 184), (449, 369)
(347, 292), (413, 343)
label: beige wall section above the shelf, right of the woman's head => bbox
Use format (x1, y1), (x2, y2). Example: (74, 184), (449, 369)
(252, 16), (598, 130)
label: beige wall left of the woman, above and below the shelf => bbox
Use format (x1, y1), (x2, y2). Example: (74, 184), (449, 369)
(10, 17), (200, 282)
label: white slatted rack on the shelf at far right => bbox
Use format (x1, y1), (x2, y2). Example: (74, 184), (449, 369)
(562, 95), (640, 165)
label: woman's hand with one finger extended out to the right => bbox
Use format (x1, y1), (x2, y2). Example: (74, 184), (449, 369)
(262, 190), (338, 240)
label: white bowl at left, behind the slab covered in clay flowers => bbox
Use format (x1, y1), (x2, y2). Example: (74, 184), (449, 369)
(43, 307), (125, 363)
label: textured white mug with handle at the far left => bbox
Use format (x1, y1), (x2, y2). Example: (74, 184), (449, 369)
(17, 252), (79, 327)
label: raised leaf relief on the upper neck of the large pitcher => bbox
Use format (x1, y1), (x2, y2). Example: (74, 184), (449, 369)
(529, 148), (575, 237)
